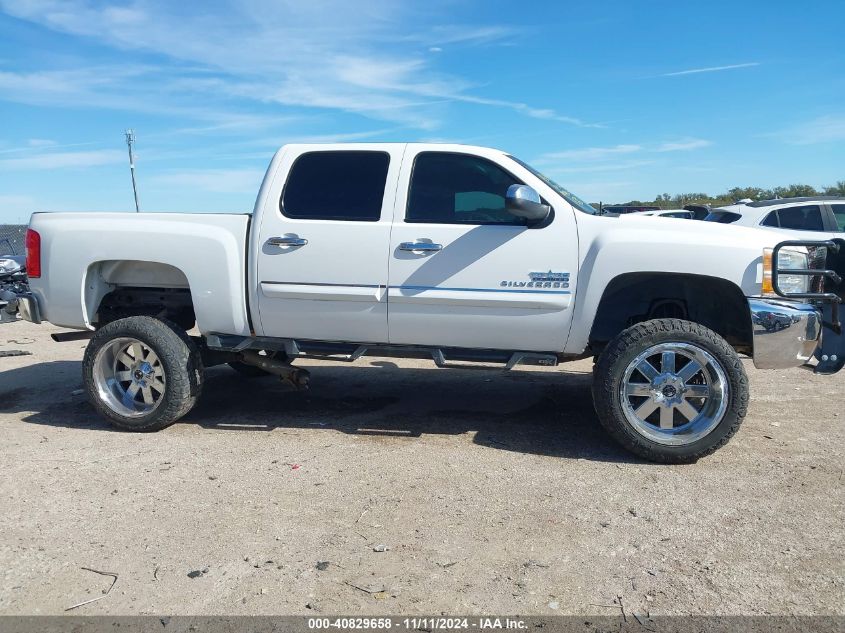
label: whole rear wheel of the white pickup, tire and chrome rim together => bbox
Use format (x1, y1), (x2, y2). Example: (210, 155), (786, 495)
(82, 316), (203, 431)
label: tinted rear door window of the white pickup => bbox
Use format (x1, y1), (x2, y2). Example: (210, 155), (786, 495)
(280, 152), (390, 222)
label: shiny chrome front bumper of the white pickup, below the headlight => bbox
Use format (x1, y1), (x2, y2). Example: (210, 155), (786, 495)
(748, 299), (822, 369)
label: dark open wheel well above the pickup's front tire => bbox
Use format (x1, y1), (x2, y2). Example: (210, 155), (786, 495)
(590, 273), (753, 353)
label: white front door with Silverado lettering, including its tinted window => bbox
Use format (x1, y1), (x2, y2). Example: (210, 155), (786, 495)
(388, 145), (578, 351)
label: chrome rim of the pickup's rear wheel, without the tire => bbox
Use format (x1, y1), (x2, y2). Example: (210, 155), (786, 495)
(94, 338), (167, 418)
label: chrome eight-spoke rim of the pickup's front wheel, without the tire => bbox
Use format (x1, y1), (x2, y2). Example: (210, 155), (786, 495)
(620, 343), (730, 446)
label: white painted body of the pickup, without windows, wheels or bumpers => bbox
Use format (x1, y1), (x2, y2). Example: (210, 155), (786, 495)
(31, 144), (778, 355)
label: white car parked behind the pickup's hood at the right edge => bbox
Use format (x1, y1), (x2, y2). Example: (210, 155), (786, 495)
(705, 196), (845, 239)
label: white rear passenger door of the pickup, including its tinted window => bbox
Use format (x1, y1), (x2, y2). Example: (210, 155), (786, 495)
(253, 144), (404, 343)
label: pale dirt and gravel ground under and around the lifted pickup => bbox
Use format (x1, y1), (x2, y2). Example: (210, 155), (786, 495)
(0, 323), (845, 615)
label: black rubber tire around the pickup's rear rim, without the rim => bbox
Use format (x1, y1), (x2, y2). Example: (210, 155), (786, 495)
(82, 316), (204, 431)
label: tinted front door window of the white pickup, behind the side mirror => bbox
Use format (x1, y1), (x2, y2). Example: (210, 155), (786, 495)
(405, 152), (525, 225)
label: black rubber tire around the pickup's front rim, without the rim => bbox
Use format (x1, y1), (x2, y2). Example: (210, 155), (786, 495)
(593, 319), (748, 464)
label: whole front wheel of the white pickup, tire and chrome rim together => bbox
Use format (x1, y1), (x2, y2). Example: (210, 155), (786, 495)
(593, 319), (748, 464)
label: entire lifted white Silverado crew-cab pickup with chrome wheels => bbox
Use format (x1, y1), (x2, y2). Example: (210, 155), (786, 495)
(7, 143), (845, 462)
